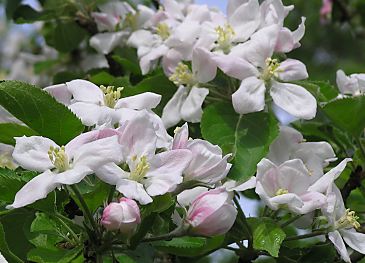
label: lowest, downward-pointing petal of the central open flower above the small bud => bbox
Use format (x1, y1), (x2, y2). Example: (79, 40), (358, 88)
(116, 179), (153, 205)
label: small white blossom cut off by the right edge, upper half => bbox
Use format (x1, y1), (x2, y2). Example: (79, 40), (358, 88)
(336, 70), (365, 96)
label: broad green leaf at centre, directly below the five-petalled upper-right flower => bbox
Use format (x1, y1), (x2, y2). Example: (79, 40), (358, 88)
(201, 103), (279, 181)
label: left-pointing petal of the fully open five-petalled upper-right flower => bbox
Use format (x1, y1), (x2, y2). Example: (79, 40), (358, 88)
(212, 55), (260, 80)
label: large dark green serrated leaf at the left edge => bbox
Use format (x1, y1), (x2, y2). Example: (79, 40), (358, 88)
(0, 81), (84, 145)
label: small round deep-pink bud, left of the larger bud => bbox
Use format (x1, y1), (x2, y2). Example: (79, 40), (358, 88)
(101, 197), (141, 235)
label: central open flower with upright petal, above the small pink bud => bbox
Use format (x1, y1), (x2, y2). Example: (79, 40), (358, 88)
(96, 115), (191, 204)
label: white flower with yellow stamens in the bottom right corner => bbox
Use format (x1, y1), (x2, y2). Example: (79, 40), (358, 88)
(322, 185), (365, 262)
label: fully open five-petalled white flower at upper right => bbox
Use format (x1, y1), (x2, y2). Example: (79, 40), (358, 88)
(214, 25), (317, 119)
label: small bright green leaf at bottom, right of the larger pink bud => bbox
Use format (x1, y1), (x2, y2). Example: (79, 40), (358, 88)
(247, 218), (286, 257)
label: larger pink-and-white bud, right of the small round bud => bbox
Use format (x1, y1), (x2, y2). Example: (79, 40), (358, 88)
(187, 188), (237, 236)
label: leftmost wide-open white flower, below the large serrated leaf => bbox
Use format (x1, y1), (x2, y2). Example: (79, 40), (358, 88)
(7, 132), (121, 208)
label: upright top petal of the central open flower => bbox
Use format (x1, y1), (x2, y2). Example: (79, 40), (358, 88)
(119, 113), (157, 158)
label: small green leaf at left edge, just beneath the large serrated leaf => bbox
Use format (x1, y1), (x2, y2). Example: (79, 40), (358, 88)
(0, 123), (37, 145)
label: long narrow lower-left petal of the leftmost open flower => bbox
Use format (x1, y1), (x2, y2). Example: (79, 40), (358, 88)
(6, 170), (59, 209)
